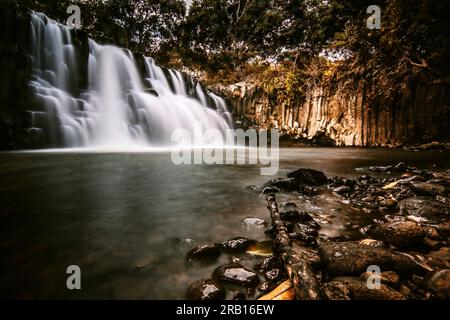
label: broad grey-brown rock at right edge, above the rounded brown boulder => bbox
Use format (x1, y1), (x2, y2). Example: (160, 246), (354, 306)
(399, 197), (450, 221)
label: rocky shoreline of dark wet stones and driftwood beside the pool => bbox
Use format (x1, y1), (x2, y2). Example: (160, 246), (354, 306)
(186, 163), (450, 300)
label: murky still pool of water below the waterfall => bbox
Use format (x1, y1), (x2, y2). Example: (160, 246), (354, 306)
(0, 148), (450, 299)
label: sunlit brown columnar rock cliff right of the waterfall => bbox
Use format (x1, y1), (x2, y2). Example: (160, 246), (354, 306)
(220, 79), (450, 146)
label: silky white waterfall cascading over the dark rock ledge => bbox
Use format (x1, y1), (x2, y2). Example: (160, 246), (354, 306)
(29, 13), (231, 148)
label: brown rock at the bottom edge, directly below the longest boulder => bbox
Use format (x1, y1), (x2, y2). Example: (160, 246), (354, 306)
(327, 277), (405, 300)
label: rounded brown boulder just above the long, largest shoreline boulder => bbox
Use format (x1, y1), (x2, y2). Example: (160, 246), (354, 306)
(371, 221), (425, 248)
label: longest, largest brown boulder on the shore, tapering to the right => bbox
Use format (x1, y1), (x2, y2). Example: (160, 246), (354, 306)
(319, 242), (425, 276)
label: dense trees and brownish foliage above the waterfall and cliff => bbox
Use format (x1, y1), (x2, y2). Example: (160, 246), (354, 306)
(5, 0), (450, 106)
